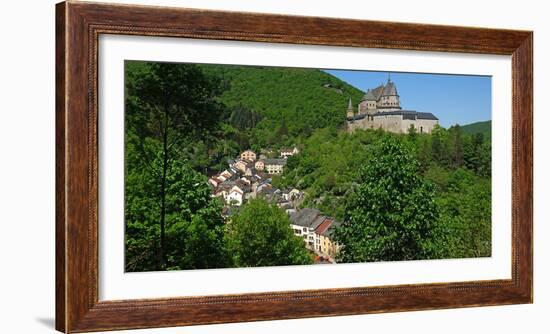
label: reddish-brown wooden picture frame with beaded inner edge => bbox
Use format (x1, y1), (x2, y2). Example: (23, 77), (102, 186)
(56, 1), (533, 333)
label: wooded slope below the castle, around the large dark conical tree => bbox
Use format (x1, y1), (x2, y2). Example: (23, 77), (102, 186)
(273, 126), (491, 258)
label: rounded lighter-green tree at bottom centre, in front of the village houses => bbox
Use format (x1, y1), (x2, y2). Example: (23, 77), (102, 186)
(226, 199), (312, 267)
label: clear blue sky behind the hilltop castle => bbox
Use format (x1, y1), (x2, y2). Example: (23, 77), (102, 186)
(326, 70), (491, 127)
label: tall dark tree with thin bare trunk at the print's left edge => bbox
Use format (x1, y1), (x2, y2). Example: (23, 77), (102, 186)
(126, 63), (223, 270)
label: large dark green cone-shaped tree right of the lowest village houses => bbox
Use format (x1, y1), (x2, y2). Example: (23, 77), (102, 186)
(335, 136), (437, 262)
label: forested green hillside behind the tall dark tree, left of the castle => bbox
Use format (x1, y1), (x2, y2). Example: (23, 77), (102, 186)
(125, 61), (363, 173)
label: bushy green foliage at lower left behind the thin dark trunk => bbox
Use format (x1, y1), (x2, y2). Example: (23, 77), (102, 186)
(125, 154), (227, 271)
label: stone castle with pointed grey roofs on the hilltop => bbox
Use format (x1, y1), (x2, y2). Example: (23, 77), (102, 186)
(346, 76), (438, 133)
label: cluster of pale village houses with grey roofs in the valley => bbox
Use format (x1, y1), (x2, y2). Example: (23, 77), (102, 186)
(208, 147), (339, 263)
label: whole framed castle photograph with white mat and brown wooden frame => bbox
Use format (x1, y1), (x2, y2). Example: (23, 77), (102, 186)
(56, 1), (533, 332)
